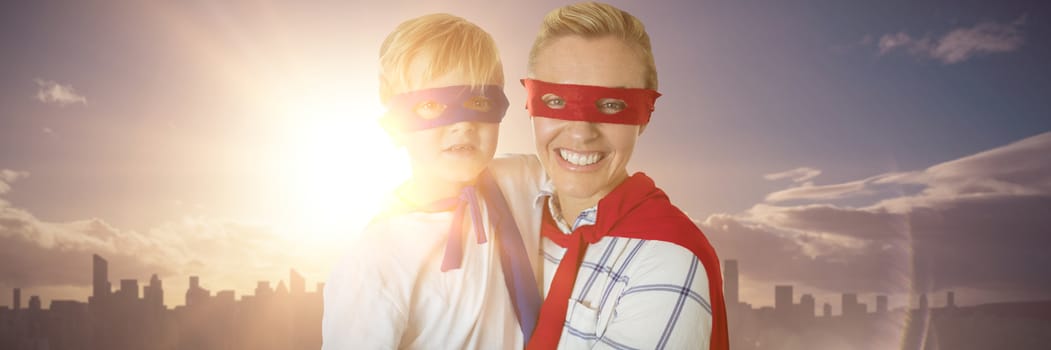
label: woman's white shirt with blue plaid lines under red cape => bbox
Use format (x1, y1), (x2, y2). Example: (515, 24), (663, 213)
(535, 182), (712, 349)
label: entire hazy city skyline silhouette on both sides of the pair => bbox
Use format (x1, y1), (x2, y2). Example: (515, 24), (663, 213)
(0, 255), (1051, 350)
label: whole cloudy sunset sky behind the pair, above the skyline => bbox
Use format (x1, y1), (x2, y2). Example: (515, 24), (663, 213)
(0, 0), (1051, 312)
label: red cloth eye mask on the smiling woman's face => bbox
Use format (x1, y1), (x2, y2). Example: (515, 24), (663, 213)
(522, 79), (660, 125)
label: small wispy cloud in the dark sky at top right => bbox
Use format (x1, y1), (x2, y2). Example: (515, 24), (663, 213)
(877, 16), (1026, 64)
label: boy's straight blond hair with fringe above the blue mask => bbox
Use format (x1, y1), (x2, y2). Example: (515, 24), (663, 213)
(379, 14), (503, 104)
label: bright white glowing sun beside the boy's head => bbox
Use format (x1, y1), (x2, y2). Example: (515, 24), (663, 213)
(286, 89), (410, 244)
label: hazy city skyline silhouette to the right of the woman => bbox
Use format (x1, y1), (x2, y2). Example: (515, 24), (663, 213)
(724, 256), (1051, 350)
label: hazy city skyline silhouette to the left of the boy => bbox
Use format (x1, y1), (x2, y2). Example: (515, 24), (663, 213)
(0, 254), (324, 350)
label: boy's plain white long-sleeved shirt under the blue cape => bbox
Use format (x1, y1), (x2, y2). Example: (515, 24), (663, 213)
(322, 156), (540, 349)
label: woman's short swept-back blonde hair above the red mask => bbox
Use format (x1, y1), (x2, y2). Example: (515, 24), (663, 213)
(528, 2), (657, 89)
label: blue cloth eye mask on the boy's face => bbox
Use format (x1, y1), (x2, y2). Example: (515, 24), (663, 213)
(382, 85), (508, 131)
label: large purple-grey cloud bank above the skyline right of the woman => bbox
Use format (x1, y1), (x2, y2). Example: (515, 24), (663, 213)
(700, 132), (1051, 297)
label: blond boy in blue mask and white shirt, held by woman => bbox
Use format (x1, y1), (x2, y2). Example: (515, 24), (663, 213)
(323, 14), (539, 349)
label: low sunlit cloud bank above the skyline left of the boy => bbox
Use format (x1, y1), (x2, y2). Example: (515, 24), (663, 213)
(0, 174), (293, 305)
